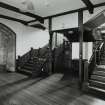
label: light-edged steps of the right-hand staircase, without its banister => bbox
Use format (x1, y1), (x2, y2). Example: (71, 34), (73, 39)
(89, 65), (105, 92)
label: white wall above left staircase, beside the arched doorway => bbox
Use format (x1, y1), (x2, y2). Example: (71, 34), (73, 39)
(0, 19), (49, 56)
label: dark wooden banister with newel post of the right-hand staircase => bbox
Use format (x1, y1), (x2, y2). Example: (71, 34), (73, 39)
(84, 41), (105, 84)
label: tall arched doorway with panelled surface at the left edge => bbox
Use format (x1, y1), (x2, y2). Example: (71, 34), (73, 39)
(0, 23), (16, 71)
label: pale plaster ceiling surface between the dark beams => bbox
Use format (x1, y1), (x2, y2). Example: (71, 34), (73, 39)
(0, 0), (105, 21)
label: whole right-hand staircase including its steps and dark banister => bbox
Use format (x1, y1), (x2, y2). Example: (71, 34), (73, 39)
(84, 42), (105, 93)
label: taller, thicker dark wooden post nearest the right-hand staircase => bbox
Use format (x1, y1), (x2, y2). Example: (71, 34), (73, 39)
(78, 11), (83, 88)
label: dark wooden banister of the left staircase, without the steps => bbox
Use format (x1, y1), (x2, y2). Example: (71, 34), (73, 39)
(17, 44), (49, 75)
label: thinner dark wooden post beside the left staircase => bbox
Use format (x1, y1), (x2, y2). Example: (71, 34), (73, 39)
(49, 18), (53, 75)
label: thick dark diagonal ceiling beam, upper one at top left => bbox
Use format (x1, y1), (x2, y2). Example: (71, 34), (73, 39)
(0, 2), (44, 23)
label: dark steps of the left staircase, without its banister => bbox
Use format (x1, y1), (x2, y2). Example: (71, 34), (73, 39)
(18, 57), (45, 76)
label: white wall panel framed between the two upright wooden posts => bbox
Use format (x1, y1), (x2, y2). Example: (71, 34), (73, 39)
(52, 13), (78, 30)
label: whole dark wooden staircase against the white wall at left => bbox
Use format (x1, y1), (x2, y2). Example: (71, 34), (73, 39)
(17, 47), (49, 77)
